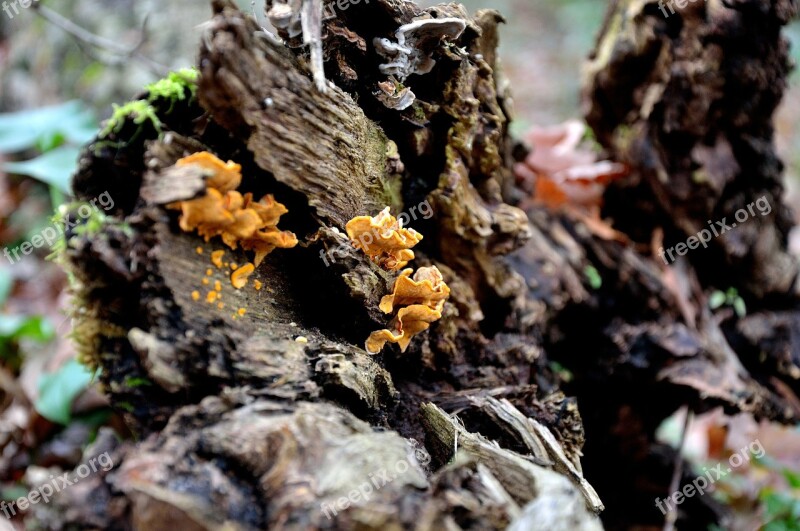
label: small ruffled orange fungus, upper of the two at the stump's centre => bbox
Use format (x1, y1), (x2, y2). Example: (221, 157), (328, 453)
(345, 207), (422, 271)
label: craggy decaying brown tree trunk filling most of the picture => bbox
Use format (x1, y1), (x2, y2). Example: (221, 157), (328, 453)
(36, 0), (800, 530)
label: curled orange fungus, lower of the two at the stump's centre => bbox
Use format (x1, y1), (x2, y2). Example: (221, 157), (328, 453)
(366, 266), (450, 354)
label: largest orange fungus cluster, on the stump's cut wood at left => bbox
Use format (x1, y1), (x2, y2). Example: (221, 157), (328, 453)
(169, 152), (297, 266)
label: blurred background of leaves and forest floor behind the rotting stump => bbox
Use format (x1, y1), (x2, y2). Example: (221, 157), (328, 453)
(0, 0), (800, 531)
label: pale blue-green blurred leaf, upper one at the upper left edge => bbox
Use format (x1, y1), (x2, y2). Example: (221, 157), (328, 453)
(0, 100), (97, 153)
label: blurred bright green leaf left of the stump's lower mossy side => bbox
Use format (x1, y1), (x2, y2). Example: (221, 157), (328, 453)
(36, 360), (93, 424)
